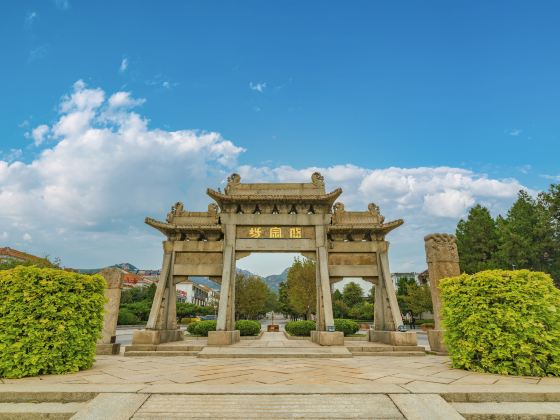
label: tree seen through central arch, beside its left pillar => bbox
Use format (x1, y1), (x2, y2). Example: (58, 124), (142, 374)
(235, 273), (269, 319)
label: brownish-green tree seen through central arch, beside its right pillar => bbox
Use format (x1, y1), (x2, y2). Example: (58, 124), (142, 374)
(286, 258), (317, 319)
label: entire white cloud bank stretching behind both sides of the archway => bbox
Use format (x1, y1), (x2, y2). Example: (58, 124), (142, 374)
(0, 81), (523, 271)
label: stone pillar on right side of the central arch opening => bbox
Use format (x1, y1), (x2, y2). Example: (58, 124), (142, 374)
(311, 225), (344, 346)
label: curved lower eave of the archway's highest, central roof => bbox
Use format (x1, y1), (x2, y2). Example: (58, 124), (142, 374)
(206, 188), (342, 207)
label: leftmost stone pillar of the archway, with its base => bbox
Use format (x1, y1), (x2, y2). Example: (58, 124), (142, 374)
(132, 241), (183, 344)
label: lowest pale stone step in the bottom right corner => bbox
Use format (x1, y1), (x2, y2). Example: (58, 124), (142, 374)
(451, 402), (560, 420)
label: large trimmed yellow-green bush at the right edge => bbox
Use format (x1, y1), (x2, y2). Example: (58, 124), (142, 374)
(440, 270), (560, 376)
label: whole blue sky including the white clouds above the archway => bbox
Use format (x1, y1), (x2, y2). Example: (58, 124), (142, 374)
(0, 0), (560, 274)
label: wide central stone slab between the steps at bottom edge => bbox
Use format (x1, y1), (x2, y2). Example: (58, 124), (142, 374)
(133, 394), (404, 419)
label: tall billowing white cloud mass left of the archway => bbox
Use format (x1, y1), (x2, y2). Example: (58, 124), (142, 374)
(0, 81), (243, 266)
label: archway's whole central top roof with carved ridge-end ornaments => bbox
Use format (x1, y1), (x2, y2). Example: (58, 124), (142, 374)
(207, 172), (342, 208)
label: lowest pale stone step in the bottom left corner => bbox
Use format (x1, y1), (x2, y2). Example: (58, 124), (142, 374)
(0, 402), (86, 420)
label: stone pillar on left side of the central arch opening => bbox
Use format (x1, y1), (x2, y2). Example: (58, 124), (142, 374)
(208, 224), (240, 346)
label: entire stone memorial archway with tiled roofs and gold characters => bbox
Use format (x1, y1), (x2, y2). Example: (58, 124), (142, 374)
(133, 173), (415, 345)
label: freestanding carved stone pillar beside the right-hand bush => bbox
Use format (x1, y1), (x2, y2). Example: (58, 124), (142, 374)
(424, 233), (461, 354)
